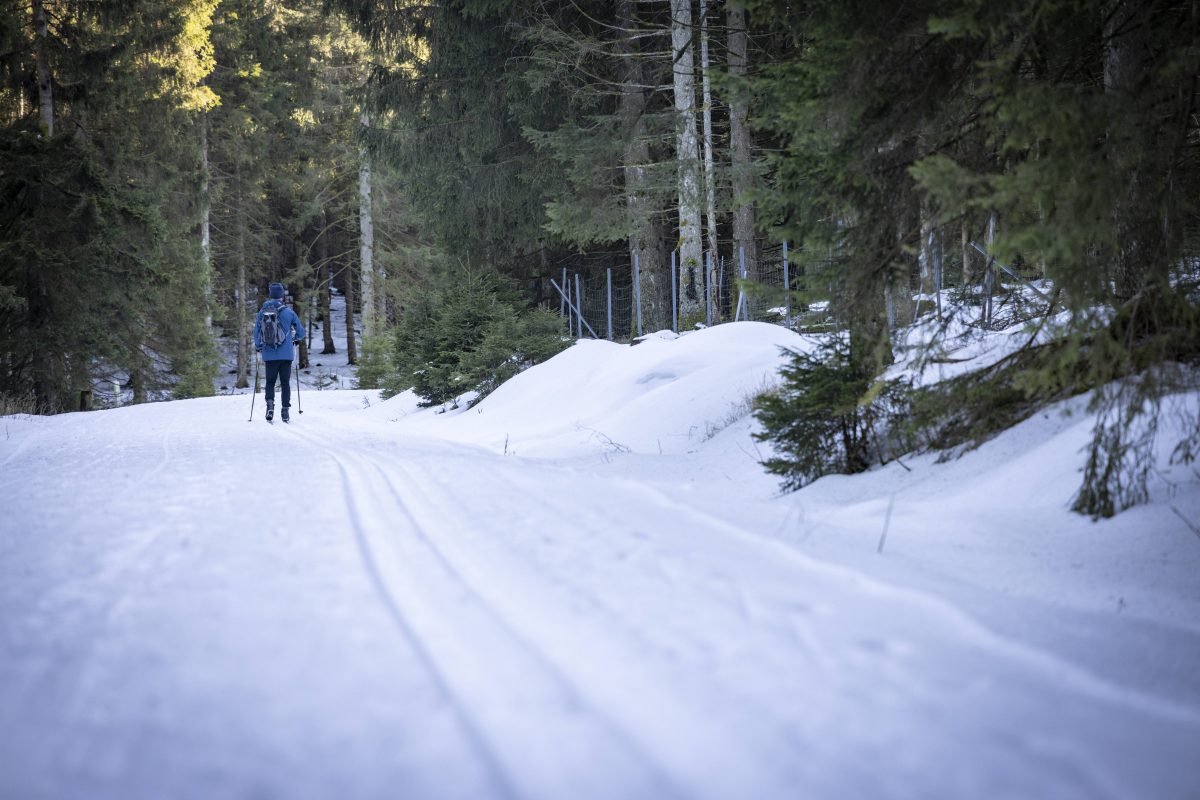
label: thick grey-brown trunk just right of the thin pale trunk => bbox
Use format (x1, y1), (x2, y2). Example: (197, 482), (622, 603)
(726, 0), (760, 281)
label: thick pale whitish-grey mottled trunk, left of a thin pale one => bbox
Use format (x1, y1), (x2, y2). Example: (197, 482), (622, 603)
(671, 0), (703, 321)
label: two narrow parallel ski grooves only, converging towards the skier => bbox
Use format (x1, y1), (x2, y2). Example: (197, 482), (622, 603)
(279, 427), (690, 799)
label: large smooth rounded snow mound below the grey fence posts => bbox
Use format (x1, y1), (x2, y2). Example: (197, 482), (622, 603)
(394, 323), (810, 457)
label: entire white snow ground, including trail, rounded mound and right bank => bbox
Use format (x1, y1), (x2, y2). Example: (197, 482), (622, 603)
(0, 323), (1200, 800)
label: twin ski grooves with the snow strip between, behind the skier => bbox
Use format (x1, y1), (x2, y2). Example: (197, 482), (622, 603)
(292, 429), (677, 798)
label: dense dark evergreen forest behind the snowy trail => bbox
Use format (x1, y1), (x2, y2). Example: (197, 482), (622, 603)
(0, 0), (1200, 513)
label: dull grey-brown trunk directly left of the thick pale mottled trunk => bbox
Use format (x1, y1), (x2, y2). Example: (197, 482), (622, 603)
(614, 0), (671, 333)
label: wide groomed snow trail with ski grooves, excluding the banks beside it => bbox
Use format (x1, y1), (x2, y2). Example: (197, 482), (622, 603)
(0, 392), (1200, 798)
